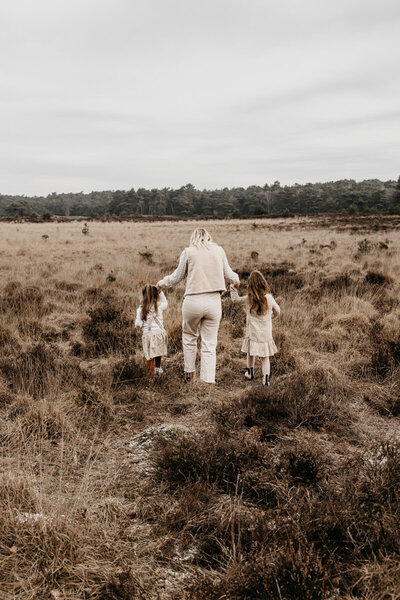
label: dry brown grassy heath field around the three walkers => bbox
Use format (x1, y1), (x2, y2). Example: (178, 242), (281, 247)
(0, 217), (400, 600)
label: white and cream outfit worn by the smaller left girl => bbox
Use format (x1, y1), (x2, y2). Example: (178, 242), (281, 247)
(135, 292), (168, 360)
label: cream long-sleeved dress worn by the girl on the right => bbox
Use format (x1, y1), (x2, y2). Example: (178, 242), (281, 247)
(230, 286), (281, 358)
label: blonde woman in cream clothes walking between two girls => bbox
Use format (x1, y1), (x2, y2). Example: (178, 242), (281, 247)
(158, 227), (239, 383)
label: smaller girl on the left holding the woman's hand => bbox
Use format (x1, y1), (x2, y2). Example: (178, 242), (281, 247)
(135, 285), (168, 377)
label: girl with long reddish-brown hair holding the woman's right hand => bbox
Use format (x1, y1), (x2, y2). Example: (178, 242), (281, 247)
(230, 271), (281, 386)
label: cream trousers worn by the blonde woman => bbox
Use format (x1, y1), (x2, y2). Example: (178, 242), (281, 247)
(182, 292), (222, 383)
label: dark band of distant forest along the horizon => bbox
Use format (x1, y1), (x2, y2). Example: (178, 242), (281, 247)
(0, 177), (400, 219)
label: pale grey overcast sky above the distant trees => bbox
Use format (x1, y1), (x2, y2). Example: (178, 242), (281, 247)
(0, 0), (400, 195)
